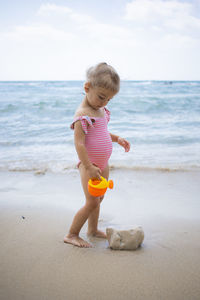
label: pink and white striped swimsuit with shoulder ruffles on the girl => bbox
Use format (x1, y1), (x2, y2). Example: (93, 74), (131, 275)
(71, 108), (112, 171)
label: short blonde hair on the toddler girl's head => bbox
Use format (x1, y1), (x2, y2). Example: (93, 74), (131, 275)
(86, 62), (120, 93)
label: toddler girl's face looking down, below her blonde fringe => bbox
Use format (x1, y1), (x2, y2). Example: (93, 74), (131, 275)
(85, 84), (115, 110)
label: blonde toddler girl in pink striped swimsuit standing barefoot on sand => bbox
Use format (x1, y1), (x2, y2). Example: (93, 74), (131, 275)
(64, 63), (130, 248)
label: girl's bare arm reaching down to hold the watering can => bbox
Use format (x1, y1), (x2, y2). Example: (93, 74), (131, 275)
(74, 121), (101, 180)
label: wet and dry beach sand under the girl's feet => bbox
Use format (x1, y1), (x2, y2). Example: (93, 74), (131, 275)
(0, 170), (200, 300)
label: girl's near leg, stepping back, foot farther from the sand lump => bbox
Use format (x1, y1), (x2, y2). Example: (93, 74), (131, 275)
(64, 164), (100, 248)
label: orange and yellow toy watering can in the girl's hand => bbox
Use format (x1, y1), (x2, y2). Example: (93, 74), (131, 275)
(88, 176), (114, 197)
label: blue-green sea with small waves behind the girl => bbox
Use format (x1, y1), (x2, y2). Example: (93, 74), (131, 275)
(0, 81), (200, 172)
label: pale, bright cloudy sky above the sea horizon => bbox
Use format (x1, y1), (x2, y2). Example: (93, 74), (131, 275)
(0, 0), (200, 80)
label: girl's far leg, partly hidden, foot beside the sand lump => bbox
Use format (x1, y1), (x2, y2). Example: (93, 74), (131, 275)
(88, 166), (109, 238)
